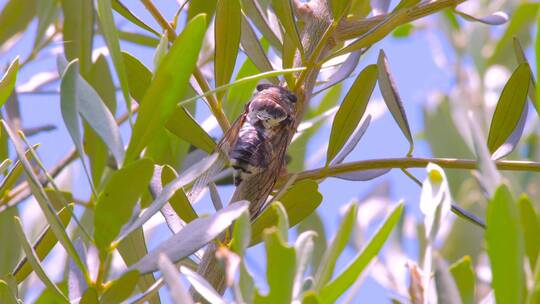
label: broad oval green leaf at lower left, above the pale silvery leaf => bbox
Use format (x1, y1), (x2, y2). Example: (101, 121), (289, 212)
(94, 158), (154, 250)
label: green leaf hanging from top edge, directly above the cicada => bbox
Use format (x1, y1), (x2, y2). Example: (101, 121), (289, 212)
(214, 0), (242, 91)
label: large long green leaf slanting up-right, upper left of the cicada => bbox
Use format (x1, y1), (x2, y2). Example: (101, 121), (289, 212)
(126, 15), (206, 163)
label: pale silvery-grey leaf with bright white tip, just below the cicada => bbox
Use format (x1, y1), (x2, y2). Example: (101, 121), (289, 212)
(131, 201), (249, 273)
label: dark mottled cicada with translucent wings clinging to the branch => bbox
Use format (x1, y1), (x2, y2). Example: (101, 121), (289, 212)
(185, 84), (296, 199)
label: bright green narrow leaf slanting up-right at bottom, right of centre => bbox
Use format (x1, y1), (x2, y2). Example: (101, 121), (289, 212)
(317, 203), (404, 303)
